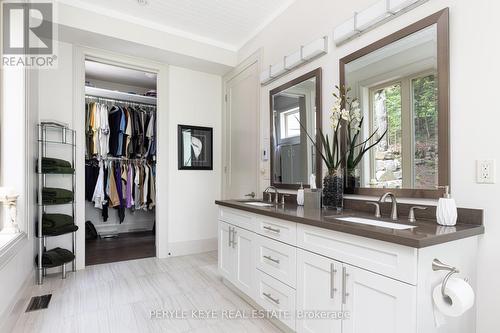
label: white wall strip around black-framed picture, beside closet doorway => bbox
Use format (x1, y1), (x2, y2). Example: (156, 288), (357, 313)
(168, 66), (222, 255)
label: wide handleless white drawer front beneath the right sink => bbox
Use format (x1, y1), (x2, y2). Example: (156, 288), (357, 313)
(297, 224), (417, 285)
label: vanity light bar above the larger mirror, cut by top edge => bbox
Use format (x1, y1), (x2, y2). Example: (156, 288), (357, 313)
(333, 0), (429, 46)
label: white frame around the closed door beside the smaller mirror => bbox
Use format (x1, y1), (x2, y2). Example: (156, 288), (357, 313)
(221, 49), (263, 199)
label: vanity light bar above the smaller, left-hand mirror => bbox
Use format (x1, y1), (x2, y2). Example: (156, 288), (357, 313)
(260, 36), (328, 86)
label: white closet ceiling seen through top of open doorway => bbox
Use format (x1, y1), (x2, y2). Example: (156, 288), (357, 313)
(85, 60), (156, 89)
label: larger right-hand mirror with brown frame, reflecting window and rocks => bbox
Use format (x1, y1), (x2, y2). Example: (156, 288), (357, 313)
(340, 9), (450, 198)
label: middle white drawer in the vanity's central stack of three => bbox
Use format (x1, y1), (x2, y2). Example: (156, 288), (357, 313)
(255, 236), (296, 288)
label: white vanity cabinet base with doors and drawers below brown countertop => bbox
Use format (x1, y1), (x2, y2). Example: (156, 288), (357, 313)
(219, 207), (477, 333)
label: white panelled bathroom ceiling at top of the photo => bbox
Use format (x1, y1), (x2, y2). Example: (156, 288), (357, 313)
(59, 0), (295, 51)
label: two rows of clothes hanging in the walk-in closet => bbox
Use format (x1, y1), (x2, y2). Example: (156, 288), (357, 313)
(85, 100), (157, 223)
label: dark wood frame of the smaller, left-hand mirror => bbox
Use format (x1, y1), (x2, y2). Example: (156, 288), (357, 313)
(269, 67), (323, 189)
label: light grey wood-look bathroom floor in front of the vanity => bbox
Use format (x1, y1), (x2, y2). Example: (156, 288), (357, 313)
(15, 252), (280, 333)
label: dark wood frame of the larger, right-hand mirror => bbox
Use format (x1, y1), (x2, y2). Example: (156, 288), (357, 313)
(339, 8), (450, 198)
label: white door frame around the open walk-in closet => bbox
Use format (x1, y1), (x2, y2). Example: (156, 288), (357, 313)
(73, 46), (170, 269)
